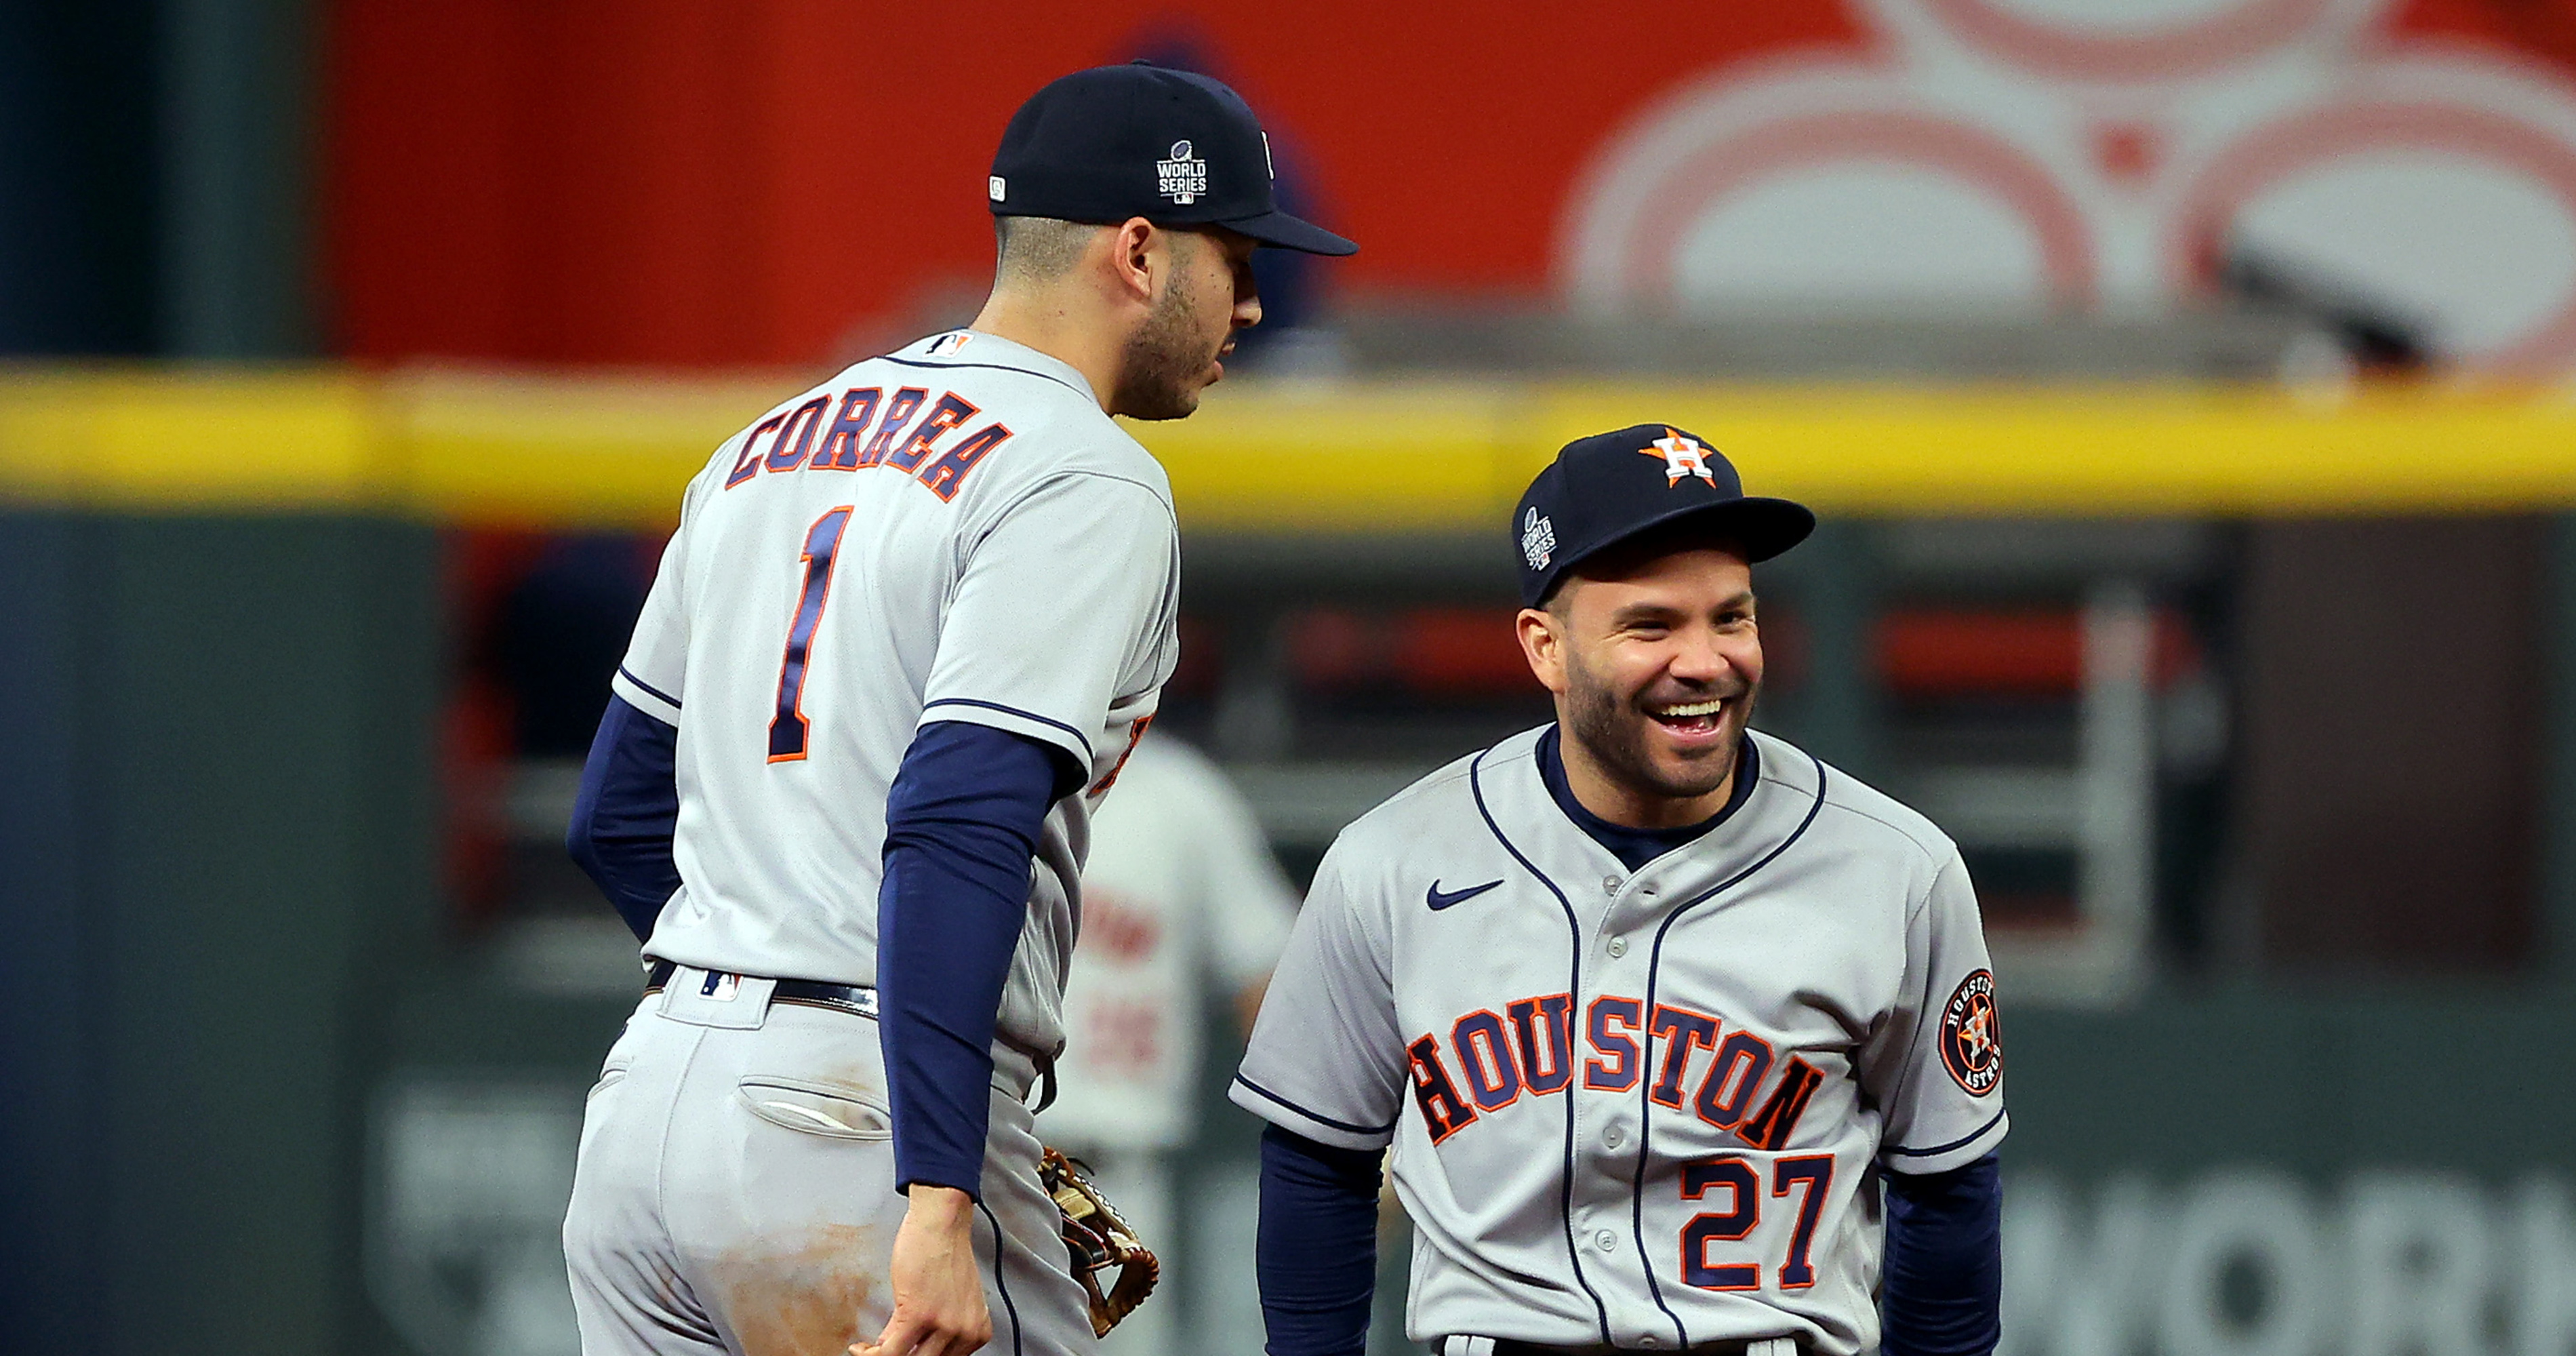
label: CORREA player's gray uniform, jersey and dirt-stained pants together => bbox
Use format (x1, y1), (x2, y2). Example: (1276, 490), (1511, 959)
(564, 332), (1180, 1356)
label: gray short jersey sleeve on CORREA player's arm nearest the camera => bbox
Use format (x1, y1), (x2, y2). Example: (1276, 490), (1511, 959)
(922, 472), (1180, 768)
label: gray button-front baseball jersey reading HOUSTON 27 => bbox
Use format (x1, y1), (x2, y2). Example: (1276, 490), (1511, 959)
(1231, 730), (2007, 1356)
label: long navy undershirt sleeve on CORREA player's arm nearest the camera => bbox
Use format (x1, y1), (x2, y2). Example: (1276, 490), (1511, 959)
(876, 722), (1082, 1199)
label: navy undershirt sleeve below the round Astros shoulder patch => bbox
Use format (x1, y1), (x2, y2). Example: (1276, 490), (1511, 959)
(1878, 1153), (2004, 1356)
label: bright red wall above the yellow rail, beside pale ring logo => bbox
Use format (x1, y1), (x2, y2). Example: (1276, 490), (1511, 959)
(325, 0), (2576, 366)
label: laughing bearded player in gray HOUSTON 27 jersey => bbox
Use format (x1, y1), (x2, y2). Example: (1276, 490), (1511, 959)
(1231, 425), (2007, 1356)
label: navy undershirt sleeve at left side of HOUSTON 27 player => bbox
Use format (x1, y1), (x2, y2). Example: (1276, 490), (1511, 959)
(1255, 1127), (1378, 1356)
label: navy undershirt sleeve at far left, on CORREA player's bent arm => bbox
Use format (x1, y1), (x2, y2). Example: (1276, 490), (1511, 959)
(564, 696), (680, 941)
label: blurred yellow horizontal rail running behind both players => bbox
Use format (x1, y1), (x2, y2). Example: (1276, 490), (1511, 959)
(0, 369), (2576, 531)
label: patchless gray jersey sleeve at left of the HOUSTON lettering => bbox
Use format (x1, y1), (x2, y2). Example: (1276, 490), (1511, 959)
(1226, 845), (1404, 1150)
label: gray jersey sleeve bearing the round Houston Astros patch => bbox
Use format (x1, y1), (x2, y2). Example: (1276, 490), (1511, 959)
(1860, 851), (2009, 1173)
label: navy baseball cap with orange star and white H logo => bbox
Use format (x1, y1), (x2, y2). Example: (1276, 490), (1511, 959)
(1512, 423), (1816, 608)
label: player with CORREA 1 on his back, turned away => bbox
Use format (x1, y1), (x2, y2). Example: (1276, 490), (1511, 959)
(564, 64), (1352, 1356)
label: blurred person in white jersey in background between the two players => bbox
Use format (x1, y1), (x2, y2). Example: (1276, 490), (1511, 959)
(1038, 735), (1295, 1356)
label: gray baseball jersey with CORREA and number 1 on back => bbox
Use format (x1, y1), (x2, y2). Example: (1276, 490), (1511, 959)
(613, 330), (1180, 1054)
